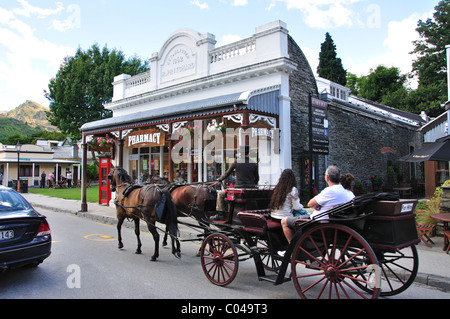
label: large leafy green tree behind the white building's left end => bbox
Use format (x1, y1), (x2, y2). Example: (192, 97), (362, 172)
(44, 44), (149, 139)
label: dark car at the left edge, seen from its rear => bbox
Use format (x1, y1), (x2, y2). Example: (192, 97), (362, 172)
(0, 185), (52, 271)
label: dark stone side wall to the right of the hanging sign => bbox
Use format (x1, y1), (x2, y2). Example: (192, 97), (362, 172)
(328, 103), (421, 191)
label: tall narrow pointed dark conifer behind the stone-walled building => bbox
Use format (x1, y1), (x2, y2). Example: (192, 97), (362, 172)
(317, 32), (347, 86)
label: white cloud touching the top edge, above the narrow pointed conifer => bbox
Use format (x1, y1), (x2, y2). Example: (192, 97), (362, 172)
(267, 0), (364, 29)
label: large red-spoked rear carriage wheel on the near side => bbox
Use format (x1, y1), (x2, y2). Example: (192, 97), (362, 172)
(291, 224), (380, 299)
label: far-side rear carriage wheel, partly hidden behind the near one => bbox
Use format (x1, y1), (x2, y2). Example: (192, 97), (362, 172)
(361, 245), (419, 296)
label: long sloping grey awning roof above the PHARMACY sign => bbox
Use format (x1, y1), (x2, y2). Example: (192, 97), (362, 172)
(80, 90), (279, 132)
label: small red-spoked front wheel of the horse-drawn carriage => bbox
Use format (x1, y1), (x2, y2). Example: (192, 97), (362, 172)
(200, 233), (239, 286)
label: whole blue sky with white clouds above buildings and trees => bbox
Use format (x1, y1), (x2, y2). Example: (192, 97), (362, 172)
(0, 0), (439, 112)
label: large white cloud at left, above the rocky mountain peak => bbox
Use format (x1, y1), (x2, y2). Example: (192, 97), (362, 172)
(0, 1), (75, 110)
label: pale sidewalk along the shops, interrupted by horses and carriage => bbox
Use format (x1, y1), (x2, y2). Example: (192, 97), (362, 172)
(22, 193), (450, 293)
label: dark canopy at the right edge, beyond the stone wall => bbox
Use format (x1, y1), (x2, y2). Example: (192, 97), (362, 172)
(399, 136), (450, 162)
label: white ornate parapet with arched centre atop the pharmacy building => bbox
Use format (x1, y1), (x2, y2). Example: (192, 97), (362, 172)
(112, 21), (289, 102)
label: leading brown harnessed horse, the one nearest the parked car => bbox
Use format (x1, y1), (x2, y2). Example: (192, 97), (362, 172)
(108, 167), (181, 261)
